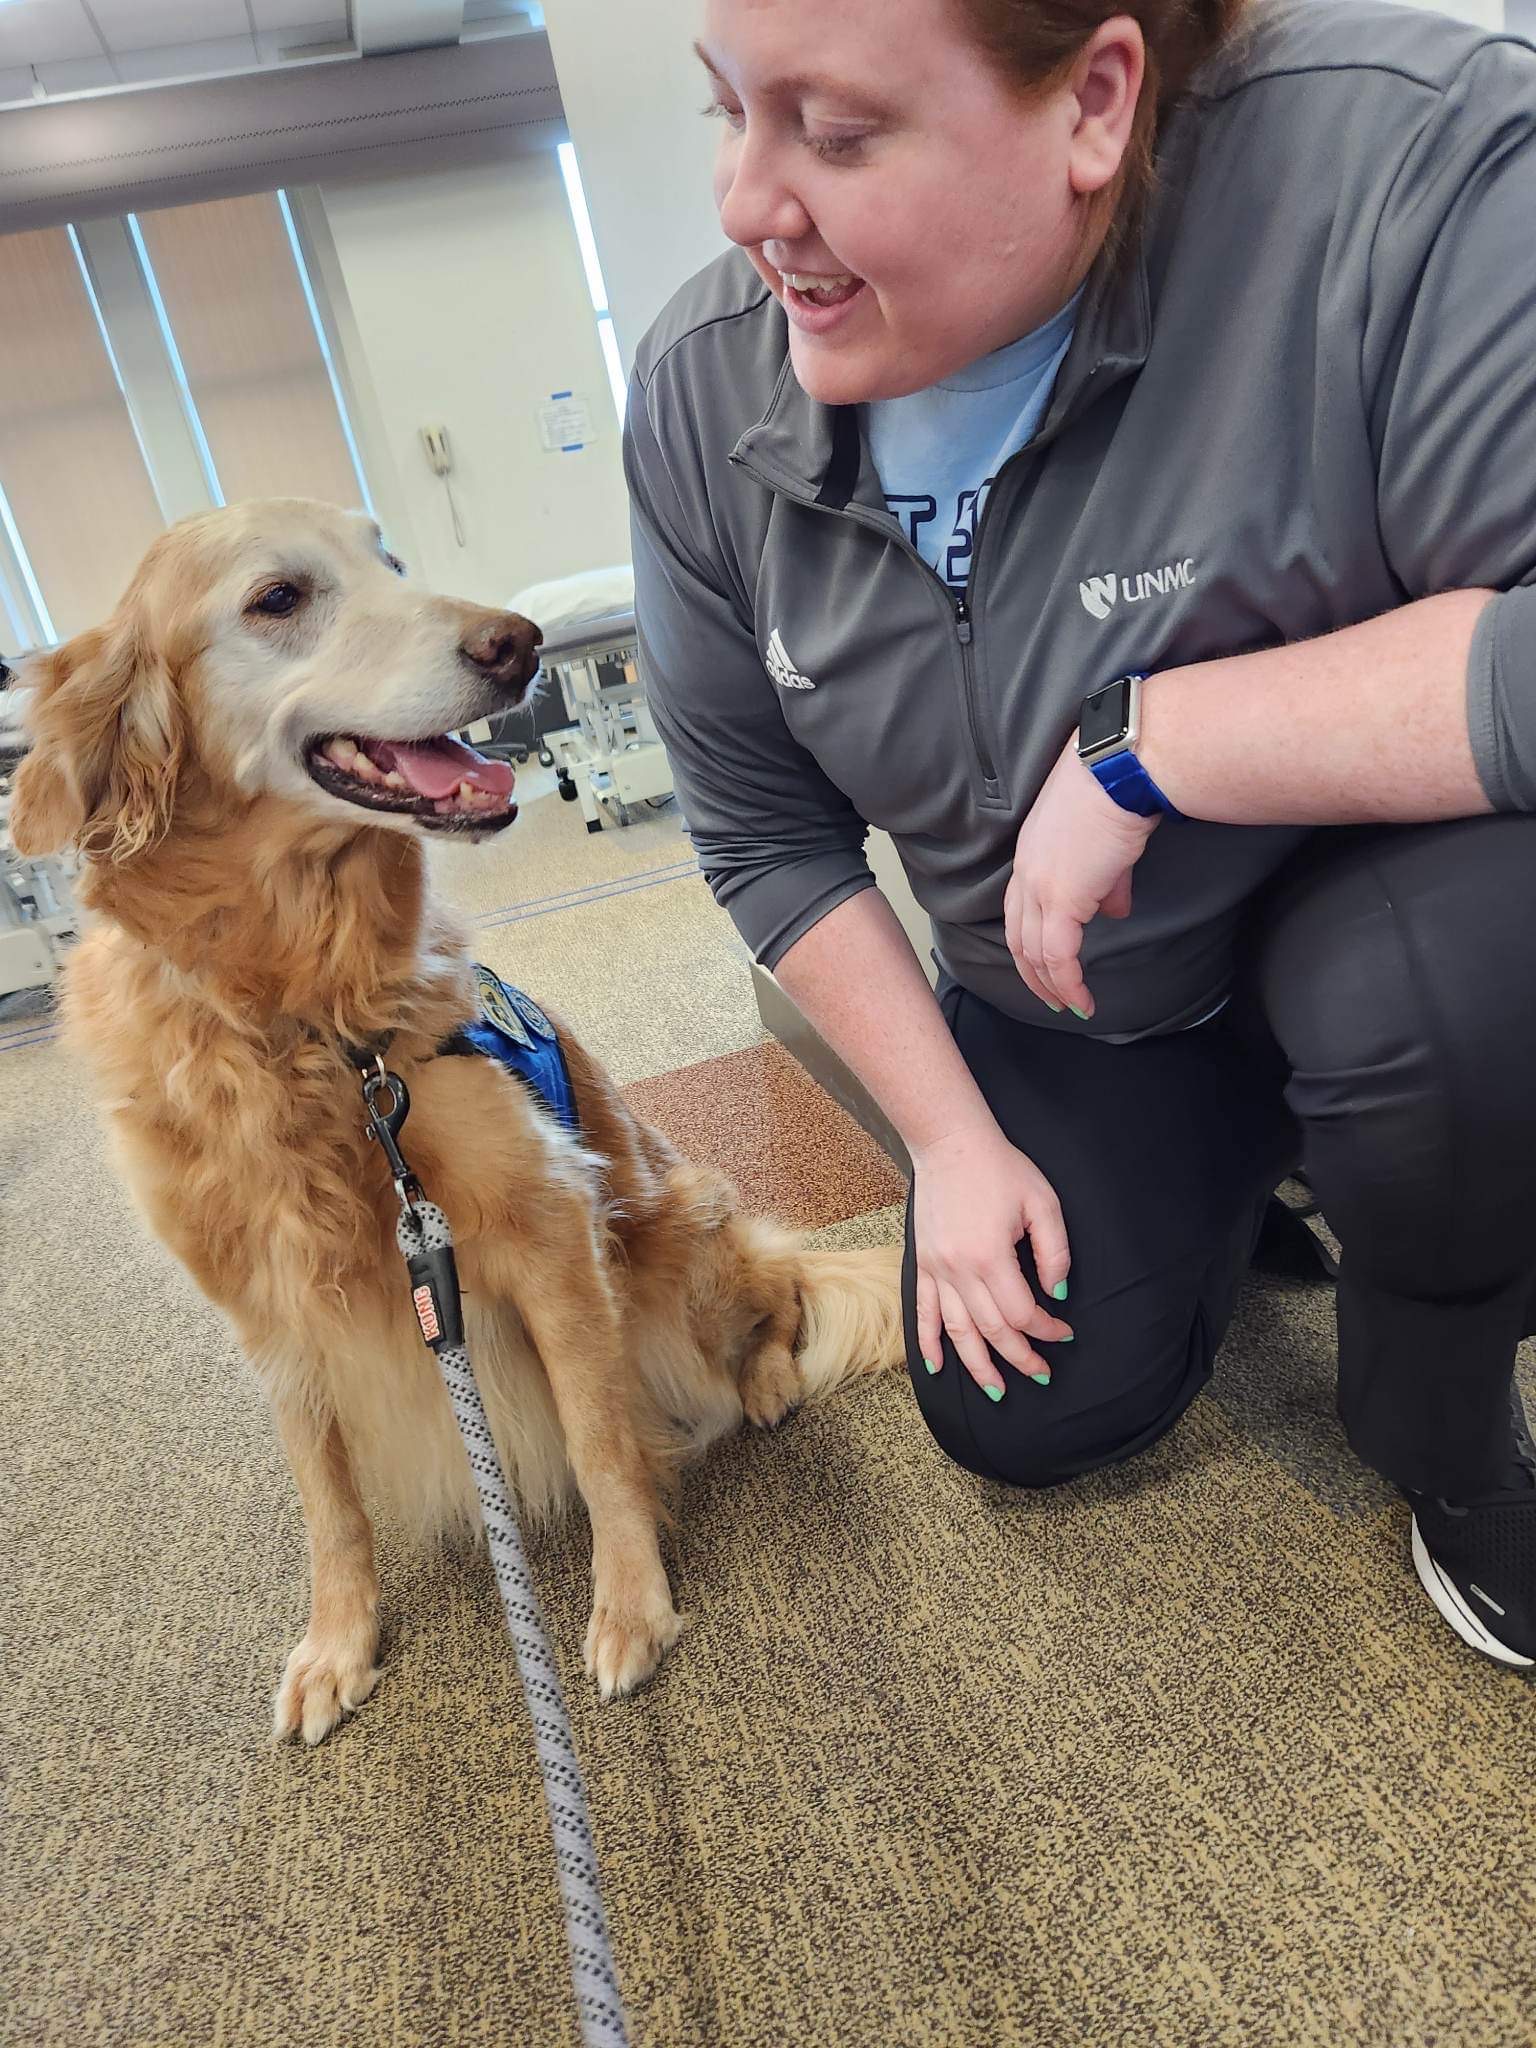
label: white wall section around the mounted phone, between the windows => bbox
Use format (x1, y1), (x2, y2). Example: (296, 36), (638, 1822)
(317, 147), (629, 604)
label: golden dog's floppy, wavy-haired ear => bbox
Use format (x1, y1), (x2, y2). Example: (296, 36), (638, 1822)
(10, 618), (186, 862)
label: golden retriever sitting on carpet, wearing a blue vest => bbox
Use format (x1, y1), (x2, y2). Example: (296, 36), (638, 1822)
(12, 500), (903, 1743)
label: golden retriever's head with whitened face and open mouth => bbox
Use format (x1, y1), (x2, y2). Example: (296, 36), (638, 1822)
(10, 500), (541, 862)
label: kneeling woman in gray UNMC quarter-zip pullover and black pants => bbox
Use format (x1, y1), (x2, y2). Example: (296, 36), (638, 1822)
(627, 0), (1536, 1665)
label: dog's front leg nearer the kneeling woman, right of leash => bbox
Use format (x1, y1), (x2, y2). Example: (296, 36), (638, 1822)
(499, 1219), (684, 1700)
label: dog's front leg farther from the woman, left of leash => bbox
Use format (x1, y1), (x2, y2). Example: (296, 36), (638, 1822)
(272, 1386), (379, 1743)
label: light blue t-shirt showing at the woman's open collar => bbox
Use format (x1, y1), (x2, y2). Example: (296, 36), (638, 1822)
(864, 291), (1081, 590)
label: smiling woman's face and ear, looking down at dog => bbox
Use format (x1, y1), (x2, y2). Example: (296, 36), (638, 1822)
(698, 0), (1145, 403)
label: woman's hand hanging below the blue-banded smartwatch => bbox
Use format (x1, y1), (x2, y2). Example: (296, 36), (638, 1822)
(1004, 739), (1159, 1018)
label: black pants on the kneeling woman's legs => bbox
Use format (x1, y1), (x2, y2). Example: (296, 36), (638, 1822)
(905, 817), (1536, 1499)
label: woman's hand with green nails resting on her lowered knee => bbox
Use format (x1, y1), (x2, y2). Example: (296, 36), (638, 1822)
(913, 1124), (1071, 1401)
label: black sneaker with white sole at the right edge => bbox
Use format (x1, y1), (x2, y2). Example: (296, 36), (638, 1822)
(1411, 1487), (1536, 1669)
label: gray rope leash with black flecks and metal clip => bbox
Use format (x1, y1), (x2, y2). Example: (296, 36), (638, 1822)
(346, 1047), (629, 2048)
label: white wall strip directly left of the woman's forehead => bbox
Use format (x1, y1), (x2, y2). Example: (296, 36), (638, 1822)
(545, 0), (727, 367)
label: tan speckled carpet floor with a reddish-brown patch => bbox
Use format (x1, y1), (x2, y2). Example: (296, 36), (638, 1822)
(0, 801), (1536, 2048)
